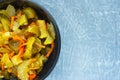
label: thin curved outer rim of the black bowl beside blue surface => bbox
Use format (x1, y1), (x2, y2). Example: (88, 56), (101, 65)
(0, 0), (61, 80)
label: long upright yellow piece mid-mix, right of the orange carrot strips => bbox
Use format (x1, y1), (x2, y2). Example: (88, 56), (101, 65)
(23, 37), (35, 59)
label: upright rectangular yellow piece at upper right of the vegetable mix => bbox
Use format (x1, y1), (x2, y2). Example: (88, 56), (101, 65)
(37, 20), (48, 38)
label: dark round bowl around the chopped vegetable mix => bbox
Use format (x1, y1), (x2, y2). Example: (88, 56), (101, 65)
(0, 0), (61, 80)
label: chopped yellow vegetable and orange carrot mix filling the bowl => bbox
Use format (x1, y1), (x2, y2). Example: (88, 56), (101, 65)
(0, 5), (55, 80)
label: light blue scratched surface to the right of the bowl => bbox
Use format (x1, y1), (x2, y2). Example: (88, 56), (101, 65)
(34, 0), (120, 80)
